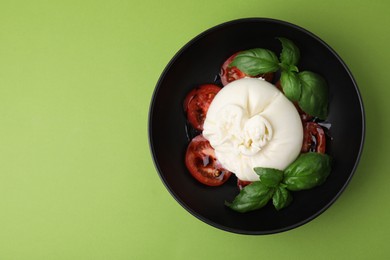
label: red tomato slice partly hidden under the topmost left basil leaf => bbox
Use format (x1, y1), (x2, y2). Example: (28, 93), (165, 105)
(220, 52), (274, 86)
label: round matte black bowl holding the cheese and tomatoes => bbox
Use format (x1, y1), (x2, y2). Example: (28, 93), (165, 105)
(149, 18), (365, 234)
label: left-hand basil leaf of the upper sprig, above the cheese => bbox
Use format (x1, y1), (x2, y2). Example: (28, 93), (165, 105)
(229, 48), (279, 76)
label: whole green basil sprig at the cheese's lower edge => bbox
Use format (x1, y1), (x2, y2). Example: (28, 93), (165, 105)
(225, 152), (331, 212)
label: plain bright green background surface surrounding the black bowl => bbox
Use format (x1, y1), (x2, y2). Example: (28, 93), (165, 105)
(0, 0), (390, 260)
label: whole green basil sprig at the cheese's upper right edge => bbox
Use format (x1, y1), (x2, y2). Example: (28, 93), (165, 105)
(229, 37), (328, 119)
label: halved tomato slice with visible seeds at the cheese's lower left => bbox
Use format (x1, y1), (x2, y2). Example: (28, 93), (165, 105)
(185, 135), (232, 186)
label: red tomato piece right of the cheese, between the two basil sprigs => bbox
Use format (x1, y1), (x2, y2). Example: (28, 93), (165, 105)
(301, 122), (326, 153)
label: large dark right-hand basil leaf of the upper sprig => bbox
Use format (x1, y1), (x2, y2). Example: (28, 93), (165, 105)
(298, 71), (328, 119)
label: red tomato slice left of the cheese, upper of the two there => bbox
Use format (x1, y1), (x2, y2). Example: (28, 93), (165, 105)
(184, 84), (221, 131)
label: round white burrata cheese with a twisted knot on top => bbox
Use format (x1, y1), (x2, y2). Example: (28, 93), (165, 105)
(203, 78), (303, 181)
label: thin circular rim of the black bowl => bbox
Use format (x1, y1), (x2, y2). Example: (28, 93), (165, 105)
(147, 17), (366, 235)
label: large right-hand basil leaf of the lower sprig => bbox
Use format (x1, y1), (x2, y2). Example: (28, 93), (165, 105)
(283, 152), (331, 191)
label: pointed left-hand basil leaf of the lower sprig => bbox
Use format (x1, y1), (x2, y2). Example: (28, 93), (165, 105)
(225, 181), (274, 213)
